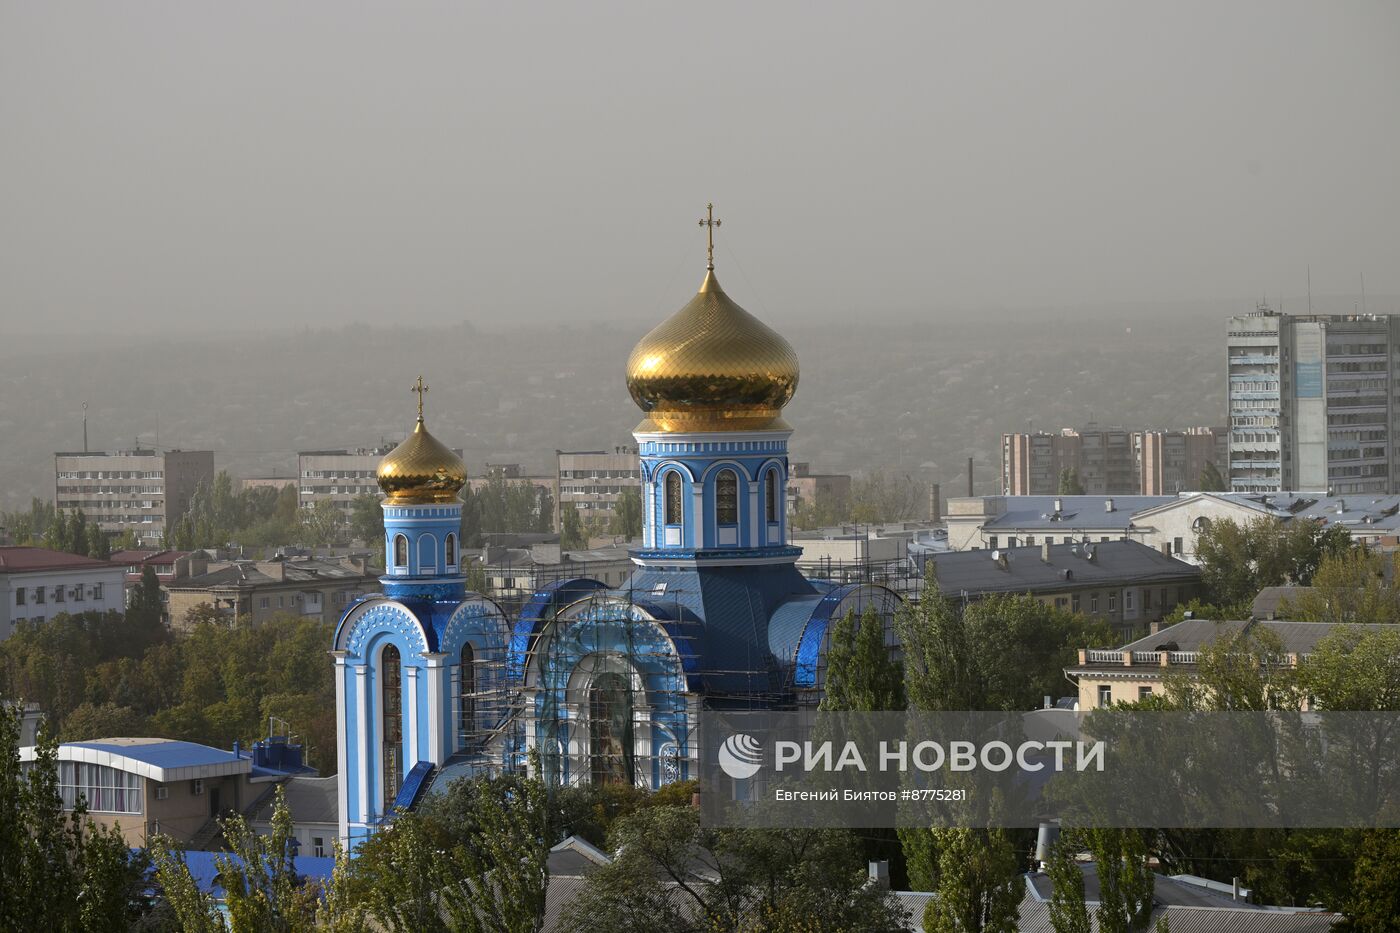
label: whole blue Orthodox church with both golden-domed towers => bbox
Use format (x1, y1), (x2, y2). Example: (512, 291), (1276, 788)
(332, 210), (899, 848)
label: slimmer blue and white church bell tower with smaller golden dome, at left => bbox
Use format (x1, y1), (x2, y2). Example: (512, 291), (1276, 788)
(333, 377), (508, 848)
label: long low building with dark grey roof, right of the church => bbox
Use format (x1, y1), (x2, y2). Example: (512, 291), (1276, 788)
(924, 541), (1201, 637)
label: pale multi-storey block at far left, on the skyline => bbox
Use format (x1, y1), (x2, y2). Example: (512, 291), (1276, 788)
(53, 448), (214, 541)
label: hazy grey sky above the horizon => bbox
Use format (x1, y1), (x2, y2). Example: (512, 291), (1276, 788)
(0, 0), (1400, 335)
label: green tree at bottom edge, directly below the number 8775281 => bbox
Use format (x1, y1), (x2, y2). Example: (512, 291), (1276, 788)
(924, 829), (1023, 933)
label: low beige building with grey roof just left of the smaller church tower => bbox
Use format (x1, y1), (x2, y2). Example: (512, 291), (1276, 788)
(164, 555), (379, 628)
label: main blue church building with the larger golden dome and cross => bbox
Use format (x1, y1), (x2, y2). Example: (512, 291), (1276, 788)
(511, 206), (897, 787)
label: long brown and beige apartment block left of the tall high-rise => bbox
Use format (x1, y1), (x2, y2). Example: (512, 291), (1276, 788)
(1001, 427), (1228, 496)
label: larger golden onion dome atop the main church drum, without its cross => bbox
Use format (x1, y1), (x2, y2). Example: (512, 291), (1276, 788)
(627, 269), (798, 433)
